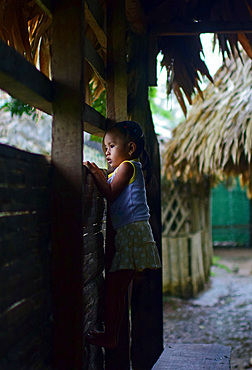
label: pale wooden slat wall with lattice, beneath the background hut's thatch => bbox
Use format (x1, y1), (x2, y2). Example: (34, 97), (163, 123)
(162, 185), (212, 298)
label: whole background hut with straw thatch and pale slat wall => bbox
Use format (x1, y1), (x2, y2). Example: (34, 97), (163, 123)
(163, 55), (252, 296)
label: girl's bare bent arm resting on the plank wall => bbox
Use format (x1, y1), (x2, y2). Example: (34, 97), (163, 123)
(84, 161), (133, 203)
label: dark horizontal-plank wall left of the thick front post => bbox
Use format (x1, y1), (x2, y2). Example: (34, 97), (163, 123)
(0, 145), (52, 370)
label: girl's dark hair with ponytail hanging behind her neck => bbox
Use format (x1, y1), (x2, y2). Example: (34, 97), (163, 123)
(104, 121), (151, 185)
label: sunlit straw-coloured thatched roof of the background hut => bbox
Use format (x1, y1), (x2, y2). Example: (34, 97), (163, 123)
(164, 55), (252, 198)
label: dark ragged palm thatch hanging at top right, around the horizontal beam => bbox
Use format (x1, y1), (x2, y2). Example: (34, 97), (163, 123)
(156, 0), (252, 115)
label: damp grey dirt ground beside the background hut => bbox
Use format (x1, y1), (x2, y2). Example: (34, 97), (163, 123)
(164, 249), (252, 370)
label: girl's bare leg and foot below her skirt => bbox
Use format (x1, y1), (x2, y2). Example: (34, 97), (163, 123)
(86, 270), (135, 349)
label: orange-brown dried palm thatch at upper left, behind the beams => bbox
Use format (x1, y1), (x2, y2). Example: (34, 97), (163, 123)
(0, 0), (106, 104)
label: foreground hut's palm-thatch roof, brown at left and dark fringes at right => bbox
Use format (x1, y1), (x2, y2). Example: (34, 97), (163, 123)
(0, 0), (252, 114)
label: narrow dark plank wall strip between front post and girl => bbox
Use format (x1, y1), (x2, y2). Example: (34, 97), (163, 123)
(83, 167), (104, 369)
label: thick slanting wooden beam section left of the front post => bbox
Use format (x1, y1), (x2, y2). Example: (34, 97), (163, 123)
(0, 41), (52, 114)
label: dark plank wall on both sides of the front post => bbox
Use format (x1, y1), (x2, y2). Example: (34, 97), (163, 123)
(0, 145), (104, 370)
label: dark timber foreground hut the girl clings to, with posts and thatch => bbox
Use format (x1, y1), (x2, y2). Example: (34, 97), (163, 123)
(0, 0), (252, 369)
